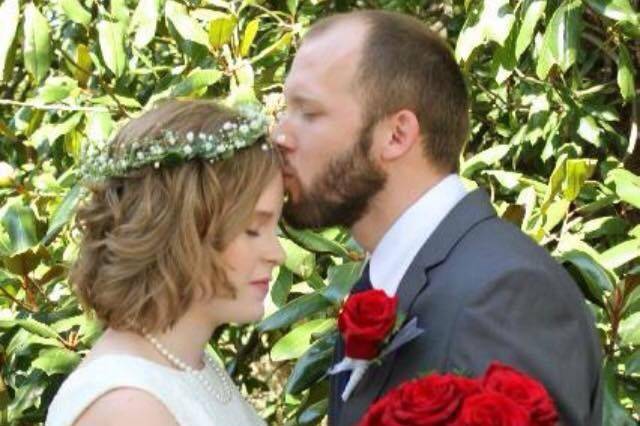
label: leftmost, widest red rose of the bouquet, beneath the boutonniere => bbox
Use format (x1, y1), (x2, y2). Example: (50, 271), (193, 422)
(360, 374), (481, 426)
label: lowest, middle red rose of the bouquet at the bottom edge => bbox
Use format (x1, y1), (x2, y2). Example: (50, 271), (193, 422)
(455, 391), (532, 426)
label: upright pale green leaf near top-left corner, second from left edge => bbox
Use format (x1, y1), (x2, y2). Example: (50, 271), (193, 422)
(22, 3), (51, 83)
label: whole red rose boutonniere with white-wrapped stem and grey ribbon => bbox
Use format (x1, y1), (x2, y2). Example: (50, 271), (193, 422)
(329, 290), (424, 401)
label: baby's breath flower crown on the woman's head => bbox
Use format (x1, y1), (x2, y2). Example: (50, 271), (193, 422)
(80, 106), (269, 181)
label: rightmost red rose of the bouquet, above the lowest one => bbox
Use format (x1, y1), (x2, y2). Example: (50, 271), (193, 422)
(483, 362), (558, 426)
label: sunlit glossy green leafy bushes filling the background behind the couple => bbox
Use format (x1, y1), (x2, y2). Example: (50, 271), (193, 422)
(0, 0), (640, 426)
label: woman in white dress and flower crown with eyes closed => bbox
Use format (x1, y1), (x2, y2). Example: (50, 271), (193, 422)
(46, 100), (284, 426)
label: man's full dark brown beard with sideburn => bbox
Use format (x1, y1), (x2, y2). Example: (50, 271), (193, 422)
(283, 125), (387, 228)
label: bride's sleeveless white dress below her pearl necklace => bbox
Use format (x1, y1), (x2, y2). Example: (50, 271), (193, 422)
(45, 354), (266, 426)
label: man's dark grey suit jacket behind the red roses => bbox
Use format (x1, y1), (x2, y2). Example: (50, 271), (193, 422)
(329, 190), (602, 426)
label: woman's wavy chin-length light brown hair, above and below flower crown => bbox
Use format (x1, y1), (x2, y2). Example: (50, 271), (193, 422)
(70, 100), (281, 332)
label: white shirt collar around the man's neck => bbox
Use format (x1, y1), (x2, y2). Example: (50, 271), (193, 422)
(369, 174), (467, 296)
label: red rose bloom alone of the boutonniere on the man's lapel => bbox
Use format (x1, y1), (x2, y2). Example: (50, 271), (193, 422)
(338, 290), (398, 359)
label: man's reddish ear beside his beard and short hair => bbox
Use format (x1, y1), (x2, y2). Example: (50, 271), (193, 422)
(380, 109), (420, 161)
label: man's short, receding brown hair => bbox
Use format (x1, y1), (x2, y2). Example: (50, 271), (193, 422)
(305, 10), (469, 171)
